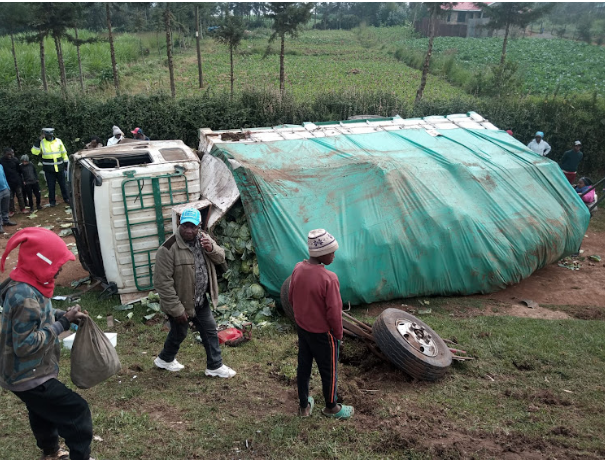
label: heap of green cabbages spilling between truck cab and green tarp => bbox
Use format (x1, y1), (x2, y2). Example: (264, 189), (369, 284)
(212, 202), (277, 328)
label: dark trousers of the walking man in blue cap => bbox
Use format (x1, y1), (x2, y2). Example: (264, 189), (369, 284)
(159, 298), (223, 370)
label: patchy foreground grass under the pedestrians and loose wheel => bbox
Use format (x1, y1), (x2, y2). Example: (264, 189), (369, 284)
(0, 241), (605, 459)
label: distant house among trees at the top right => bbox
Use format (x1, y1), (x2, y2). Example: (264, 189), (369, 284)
(414, 2), (495, 37)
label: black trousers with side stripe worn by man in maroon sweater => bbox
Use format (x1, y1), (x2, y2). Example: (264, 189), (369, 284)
(296, 327), (340, 409)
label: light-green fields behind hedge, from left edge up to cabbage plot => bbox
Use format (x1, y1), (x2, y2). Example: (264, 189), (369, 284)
(0, 27), (463, 101)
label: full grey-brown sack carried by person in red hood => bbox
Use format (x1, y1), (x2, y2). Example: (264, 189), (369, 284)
(71, 316), (122, 388)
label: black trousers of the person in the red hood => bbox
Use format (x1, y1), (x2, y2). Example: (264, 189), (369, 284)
(13, 379), (92, 459)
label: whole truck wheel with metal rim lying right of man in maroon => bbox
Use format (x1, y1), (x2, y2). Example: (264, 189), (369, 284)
(372, 308), (452, 380)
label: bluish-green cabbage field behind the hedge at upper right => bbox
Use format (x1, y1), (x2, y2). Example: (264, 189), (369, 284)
(394, 37), (605, 96)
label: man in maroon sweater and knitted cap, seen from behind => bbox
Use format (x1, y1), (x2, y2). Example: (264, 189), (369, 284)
(288, 229), (353, 419)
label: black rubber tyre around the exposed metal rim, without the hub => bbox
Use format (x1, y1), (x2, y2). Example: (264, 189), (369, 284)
(372, 308), (452, 381)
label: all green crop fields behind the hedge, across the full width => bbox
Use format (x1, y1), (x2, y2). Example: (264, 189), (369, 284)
(0, 27), (605, 100)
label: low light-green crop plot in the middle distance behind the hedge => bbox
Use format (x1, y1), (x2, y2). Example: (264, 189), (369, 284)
(119, 28), (463, 101)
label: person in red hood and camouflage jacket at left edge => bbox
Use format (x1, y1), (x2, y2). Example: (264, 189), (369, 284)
(0, 227), (92, 459)
